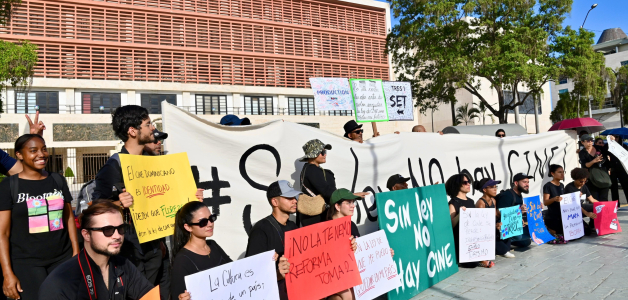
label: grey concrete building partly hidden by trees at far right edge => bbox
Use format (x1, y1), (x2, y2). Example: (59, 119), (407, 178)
(552, 28), (628, 129)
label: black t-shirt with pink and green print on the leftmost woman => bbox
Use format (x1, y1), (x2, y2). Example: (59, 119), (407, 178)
(0, 175), (72, 266)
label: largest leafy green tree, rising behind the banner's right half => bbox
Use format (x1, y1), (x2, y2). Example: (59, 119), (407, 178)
(387, 0), (593, 123)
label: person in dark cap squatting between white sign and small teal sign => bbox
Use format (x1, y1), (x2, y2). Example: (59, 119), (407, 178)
(473, 178), (515, 258)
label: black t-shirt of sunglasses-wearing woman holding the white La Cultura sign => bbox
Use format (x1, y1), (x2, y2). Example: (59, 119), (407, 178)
(170, 240), (233, 299)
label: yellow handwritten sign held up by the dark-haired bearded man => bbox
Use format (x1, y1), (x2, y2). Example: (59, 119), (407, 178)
(120, 153), (196, 243)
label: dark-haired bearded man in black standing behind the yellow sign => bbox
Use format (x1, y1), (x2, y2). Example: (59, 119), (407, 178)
(92, 105), (170, 300)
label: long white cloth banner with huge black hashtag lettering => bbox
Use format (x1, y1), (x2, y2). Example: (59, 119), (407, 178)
(162, 104), (578, 259)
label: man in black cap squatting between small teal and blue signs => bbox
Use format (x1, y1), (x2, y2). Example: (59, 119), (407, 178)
(495, 173), (533, 248)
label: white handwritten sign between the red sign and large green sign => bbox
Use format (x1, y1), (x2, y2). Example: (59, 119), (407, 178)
(353, 230), (401, 300)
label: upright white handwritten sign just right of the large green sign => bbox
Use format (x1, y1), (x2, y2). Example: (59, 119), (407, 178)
(458, 208), (495, 263)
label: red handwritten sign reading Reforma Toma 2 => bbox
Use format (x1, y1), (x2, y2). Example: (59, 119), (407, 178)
(284, 217), (362, 300)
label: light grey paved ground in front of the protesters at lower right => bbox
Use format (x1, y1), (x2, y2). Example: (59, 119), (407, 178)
(412, 204), (628, 300)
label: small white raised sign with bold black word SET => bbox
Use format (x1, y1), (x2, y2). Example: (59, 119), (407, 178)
(383, 81), (414, 121)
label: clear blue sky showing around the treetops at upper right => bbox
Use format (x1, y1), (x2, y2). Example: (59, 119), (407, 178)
(380, 0), (628, 43)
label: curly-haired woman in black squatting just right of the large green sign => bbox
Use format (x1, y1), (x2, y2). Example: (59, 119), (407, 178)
(445, 173), (495, 268)
